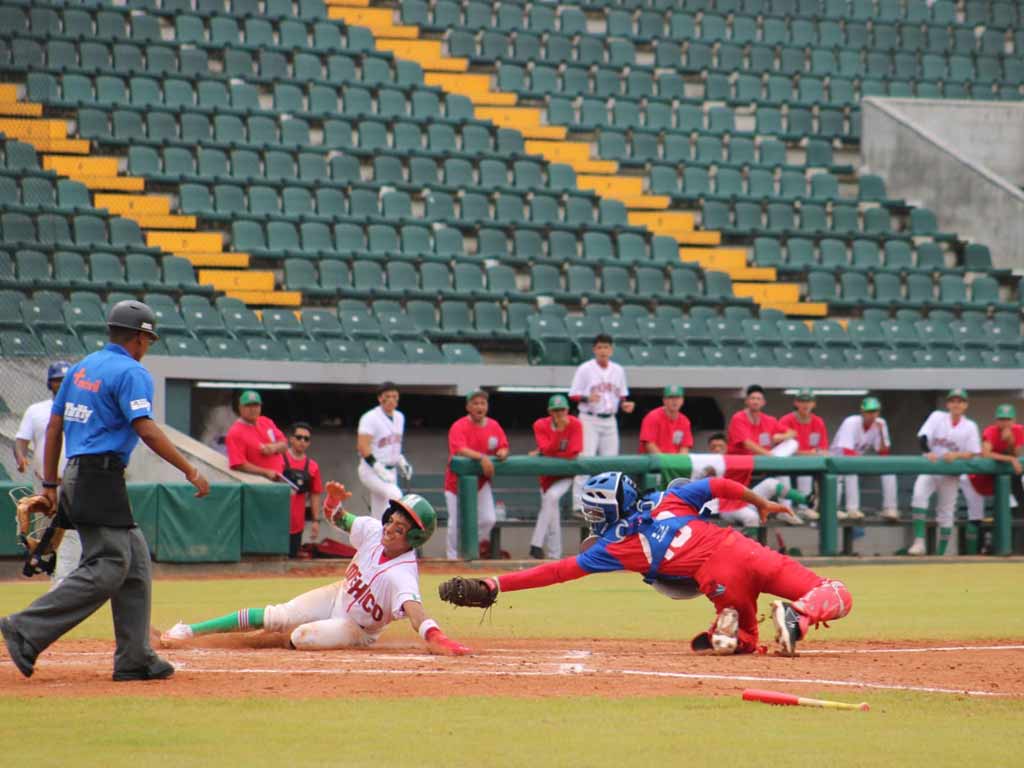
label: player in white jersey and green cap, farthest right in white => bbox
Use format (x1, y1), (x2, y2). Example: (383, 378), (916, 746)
(906, 389), (981, 555)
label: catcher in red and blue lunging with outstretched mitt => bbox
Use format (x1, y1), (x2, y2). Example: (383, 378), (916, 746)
(439, 472), (853, 655)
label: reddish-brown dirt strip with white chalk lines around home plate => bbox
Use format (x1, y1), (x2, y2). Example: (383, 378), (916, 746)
(6, 633), (1024, 698)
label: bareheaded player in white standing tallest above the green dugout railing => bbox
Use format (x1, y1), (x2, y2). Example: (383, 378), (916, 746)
(569, 334), (636, 509)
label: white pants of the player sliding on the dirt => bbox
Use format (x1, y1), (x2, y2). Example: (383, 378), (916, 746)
(263, 581), (380, 650)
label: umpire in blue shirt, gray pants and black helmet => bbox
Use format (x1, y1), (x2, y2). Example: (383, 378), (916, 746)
(0, 300), (210, 681)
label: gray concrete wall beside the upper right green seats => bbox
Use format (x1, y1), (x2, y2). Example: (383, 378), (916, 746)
(861, 97), (1024, 268)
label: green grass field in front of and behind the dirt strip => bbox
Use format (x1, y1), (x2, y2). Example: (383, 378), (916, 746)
(0, 563), (1024, 768)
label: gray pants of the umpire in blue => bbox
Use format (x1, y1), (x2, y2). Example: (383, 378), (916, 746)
(9, 465), (156, 672)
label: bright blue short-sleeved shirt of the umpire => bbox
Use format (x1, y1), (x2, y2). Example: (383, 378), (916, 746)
(51, 344), (153, 464)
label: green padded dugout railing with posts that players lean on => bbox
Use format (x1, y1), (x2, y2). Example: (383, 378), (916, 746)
(452, 455), (1013, 560)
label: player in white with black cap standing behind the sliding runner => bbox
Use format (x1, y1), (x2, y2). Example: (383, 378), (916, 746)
(355, 381), (413, 520)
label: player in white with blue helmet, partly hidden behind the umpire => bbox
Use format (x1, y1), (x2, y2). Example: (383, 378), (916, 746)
(14, 360), (82, 589)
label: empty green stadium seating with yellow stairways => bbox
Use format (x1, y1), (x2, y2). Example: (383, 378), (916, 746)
(0, 0), (1024, 368)
